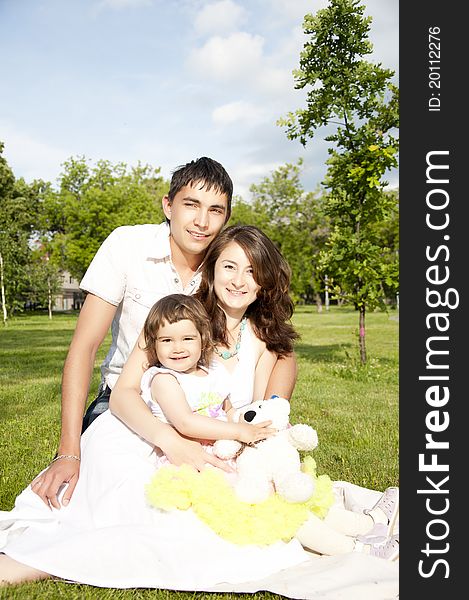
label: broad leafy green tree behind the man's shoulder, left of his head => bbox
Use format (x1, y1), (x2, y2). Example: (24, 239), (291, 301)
(41, 157), (169, 280)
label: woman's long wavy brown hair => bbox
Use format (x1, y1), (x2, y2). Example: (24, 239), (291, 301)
(195, 225), (299, 356)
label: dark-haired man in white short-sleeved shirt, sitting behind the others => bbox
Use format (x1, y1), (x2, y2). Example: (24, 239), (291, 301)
(32, 157), (296, 508)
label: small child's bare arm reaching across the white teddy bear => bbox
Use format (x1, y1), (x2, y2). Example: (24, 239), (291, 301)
(151, 373), (276, 444)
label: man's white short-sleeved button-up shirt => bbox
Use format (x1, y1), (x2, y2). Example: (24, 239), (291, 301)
(80, 223), (201, 389)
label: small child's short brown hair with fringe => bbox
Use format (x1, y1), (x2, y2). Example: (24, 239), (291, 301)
(143, 294), (214, 368)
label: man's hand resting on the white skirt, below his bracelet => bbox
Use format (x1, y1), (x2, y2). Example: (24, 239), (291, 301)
(31, 458), (80, 509)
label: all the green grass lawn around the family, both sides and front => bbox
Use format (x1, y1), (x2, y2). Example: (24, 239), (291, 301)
(0, 306), (399, 600)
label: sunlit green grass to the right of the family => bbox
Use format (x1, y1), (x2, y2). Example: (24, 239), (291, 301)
(292, 307), (399, 489)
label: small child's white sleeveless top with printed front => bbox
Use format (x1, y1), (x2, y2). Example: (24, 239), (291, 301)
(140, 362), (231, 423)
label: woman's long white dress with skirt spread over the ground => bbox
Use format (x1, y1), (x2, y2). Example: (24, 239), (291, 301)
(0, 327), (309, 591)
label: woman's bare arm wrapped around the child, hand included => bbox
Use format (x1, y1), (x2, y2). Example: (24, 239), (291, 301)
(109, 334), (231, 471)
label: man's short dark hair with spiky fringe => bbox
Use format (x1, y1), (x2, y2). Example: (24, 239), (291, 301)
(168, 156), (233, 221)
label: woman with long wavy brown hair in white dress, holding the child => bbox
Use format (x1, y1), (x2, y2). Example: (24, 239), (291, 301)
(0, 227), (308, 590)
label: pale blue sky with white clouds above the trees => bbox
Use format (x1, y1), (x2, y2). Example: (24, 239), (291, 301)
(0, 0), (399, 200)
